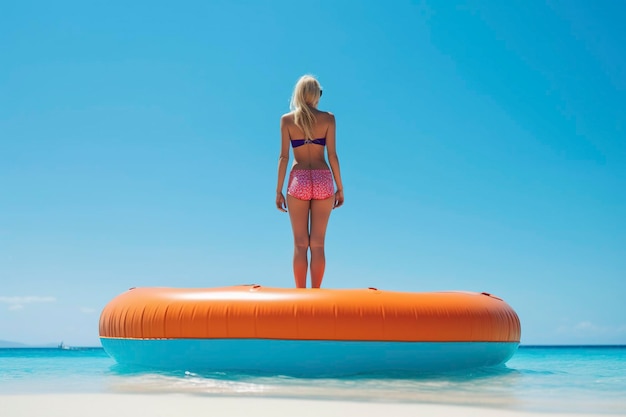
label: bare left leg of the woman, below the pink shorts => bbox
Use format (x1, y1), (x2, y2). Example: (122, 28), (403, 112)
(287, 194), (311, 288)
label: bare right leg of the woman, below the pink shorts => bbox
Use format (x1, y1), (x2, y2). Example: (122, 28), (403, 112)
(309, 195), (335, 288)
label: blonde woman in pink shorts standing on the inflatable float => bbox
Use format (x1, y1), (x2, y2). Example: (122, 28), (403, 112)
(276, 75), (343, 288)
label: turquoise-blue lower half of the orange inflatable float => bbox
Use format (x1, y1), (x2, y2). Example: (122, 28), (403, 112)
(100, 338), (519, 376)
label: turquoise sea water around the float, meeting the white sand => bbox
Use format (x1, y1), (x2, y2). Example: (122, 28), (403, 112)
(0, 346), (626, 415)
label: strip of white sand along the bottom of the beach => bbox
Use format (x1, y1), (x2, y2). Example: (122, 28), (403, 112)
(0, 394), (606, 417)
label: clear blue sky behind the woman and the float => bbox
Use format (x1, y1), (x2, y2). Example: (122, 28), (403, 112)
(0, 0), (626, 345)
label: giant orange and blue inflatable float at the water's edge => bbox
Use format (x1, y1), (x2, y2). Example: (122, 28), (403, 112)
(99, 285), (521, 376)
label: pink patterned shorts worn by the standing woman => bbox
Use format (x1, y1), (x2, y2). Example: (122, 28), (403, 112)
(287, 169), (335, 200)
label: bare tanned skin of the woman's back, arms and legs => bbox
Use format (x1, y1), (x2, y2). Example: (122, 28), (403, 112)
(276, 102), (343, 288)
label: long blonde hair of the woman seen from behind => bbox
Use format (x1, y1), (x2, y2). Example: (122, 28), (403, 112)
(289, 75), (322, 139)
